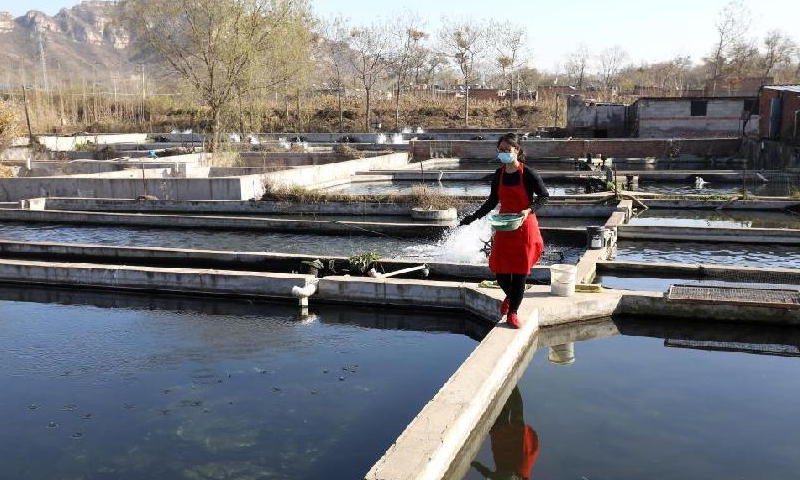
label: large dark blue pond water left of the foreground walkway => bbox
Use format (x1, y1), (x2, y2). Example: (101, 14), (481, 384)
(0, 289), (486, 480)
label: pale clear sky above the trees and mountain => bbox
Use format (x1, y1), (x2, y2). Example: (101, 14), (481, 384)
(6, 0), (800, 71)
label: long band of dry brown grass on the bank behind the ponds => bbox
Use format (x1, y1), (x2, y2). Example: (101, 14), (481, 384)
(7, 89), (565, 134)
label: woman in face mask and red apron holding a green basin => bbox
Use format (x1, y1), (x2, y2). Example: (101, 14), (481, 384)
(461, 133), (550, 328)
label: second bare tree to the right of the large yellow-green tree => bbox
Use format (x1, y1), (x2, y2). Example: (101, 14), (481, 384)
(350, 24), (389, 132)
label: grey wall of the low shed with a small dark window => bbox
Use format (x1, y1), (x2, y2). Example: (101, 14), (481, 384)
(631, 98), (758, 138)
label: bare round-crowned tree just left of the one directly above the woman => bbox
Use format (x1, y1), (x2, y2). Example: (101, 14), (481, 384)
(439, 20), (488, 127)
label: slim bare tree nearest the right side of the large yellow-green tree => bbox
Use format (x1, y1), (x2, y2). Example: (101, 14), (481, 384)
(320, 17), (352, 132)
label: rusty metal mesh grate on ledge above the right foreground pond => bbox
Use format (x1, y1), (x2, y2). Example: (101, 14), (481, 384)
(667, 285), (800, 309)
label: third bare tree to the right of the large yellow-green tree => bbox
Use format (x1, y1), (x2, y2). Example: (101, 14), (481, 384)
(389, 12), (428, 131)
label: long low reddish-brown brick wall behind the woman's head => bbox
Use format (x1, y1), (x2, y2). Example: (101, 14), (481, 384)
(410, 138), (741, 161)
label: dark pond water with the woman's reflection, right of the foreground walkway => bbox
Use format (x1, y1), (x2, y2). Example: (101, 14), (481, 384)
(466, 320), (800, 480)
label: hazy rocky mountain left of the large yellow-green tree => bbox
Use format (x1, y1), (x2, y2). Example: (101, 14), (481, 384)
(0, 0), (136, 87)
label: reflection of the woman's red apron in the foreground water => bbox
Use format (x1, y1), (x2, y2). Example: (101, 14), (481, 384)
(471, 387), (539, 480)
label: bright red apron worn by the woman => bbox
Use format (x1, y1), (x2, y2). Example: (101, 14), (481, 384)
(489, 163), (544, 275)
